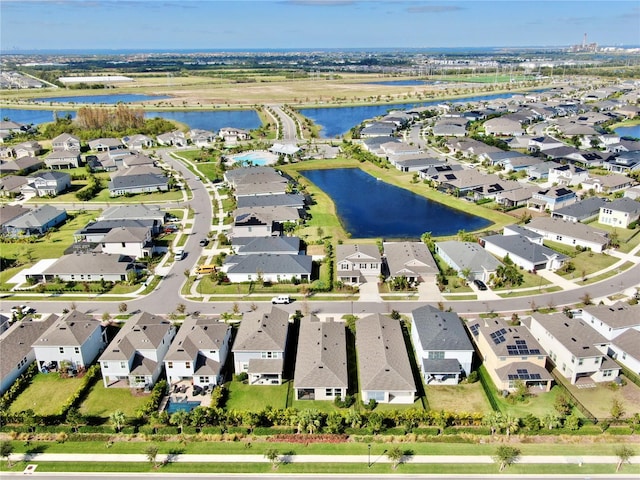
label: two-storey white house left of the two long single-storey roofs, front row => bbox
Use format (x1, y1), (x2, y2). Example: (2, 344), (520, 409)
(232, 307), (289, 385)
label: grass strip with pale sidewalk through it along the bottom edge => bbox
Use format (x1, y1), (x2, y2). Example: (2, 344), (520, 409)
(3, 435), (640, 475)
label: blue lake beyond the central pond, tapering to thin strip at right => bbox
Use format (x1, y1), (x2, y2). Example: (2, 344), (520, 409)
(299, 90), (538, 138)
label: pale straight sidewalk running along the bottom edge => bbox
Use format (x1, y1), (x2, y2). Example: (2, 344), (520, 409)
(10, 452), (640, 465)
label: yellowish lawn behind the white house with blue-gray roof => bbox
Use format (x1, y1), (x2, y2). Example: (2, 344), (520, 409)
(425, 382), (492, 413)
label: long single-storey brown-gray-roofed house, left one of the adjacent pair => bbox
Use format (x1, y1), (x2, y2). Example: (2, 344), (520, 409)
(293, 315), (349, 401)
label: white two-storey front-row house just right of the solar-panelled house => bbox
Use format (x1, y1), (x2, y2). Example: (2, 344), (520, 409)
(529, 313), (620, 385)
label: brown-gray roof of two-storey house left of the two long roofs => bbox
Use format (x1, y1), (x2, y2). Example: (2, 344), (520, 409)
(233, 307), (289, 352)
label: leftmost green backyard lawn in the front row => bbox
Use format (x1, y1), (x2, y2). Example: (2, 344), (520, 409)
(10, 373), (82, 415)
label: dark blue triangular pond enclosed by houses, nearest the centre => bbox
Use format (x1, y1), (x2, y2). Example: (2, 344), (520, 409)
(300, 168), (491, 240)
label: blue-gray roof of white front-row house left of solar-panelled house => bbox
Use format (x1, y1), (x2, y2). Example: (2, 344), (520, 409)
(411, 305), (473, 351)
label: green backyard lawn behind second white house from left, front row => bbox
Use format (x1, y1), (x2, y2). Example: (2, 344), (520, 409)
(80, 379), (149, 418)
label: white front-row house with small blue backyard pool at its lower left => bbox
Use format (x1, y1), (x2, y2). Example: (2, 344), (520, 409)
(164, 317), (231, 387)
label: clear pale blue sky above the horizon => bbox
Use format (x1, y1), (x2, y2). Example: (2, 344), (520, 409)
(0, 0), (640, 53)
